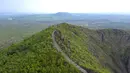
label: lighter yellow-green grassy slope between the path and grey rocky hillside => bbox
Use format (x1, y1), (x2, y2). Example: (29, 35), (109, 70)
(54, 23), (110, 73)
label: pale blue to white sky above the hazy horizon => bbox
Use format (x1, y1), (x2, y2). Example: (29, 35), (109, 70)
(0, 0), (130, 13)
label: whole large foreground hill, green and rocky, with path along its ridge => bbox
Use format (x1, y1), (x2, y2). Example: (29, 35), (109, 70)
(0, 23), (130, 73)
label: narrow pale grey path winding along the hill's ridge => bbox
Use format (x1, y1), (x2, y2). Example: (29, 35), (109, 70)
(52, 30), (88, 73)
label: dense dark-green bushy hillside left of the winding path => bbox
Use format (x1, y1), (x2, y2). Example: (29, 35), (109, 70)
(0, 27), (79, 73)
